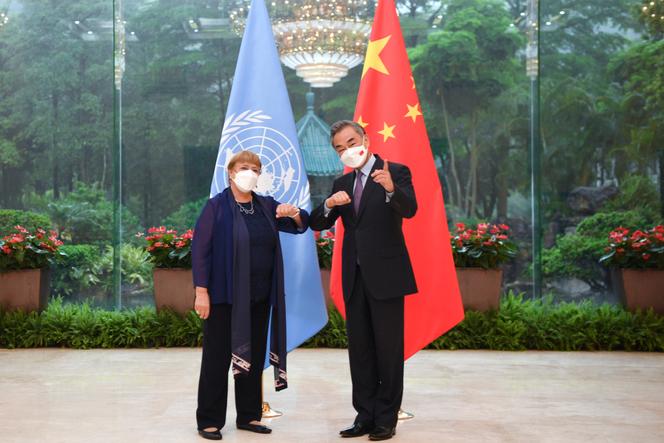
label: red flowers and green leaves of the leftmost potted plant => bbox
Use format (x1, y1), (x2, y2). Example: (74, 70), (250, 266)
(0, 225), (66, 271)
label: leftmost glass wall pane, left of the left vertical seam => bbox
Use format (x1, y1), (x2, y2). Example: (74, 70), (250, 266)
(0, 0), (115, 305)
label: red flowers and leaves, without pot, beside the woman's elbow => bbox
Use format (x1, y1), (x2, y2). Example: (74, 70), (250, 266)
(136, 226), (194, 268)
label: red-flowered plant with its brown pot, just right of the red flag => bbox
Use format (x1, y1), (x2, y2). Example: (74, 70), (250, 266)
(451, 223), (517, 311)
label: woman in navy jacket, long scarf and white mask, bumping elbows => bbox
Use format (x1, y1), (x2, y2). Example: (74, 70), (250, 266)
(192, 151), (309, 440)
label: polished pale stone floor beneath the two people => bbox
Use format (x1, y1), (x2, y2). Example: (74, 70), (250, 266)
(0, 349), (664, 443)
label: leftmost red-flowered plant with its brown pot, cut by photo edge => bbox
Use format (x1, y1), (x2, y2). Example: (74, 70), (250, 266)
(0, 225), (65, 311)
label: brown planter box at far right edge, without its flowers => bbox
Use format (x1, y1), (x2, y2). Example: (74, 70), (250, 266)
(611, 268), (664, 315)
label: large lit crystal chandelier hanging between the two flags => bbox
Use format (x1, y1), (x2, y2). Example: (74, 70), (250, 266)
(230, 0), (373, 88)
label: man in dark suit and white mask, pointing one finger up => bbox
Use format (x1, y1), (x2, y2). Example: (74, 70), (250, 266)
(309, 120), (417, 440)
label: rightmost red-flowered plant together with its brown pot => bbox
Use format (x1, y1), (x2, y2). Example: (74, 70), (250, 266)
(599, 225), (664, 314)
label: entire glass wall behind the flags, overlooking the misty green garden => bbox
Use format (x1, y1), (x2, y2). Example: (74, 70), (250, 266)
(0, 0), (664, 308)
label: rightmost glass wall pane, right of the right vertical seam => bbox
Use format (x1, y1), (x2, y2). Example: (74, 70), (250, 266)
(540, 0), (664, 302)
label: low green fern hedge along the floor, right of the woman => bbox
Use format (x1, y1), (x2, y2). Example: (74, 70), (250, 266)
(304, 293), (664, 352)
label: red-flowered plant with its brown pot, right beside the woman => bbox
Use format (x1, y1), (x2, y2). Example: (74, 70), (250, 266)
(137, 226), (195, 314)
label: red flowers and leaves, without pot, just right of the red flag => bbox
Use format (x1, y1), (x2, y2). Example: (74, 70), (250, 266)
(451, 223), (518, 269)
